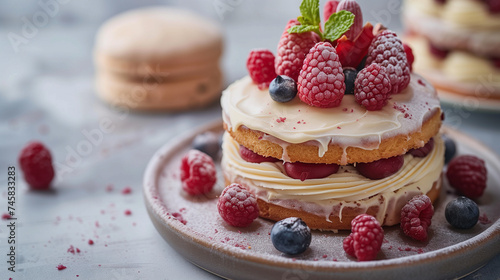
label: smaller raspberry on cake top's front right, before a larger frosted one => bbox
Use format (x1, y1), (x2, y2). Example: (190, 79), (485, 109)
(354, 63), (392, 111)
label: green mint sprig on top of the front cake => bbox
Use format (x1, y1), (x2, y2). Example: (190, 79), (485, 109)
(287, 0), (354, 41)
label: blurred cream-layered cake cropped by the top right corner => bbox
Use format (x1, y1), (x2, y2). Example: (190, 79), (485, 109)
(403, 0), (500, 100)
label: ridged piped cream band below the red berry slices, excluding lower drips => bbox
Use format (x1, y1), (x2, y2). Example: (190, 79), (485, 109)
(222, 133), (444, 204)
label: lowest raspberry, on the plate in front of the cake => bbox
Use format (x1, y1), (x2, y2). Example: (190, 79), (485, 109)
(343, 214), (384, 261)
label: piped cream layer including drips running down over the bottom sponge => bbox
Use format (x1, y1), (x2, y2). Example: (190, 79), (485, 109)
(222, 133), (444, 225)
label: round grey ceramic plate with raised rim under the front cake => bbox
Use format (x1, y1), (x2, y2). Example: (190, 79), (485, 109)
(144, 121), (500, 279)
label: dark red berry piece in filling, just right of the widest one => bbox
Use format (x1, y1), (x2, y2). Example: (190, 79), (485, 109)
(356, 155), (405, 180)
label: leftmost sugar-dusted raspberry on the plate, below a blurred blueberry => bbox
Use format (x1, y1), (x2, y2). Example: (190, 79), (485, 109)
(181, 149), (217, 195)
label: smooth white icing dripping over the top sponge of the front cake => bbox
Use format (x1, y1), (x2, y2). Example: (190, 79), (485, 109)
(221, 74), (440, 160)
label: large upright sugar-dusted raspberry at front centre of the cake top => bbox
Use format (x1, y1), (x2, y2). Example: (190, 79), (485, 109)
(297, 42), (345, 108)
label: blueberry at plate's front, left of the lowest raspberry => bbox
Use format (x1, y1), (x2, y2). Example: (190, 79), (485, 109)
(271, 217), (311, 255)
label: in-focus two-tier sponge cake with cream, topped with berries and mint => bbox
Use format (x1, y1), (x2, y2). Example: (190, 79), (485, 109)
(221, 0), (444, 230)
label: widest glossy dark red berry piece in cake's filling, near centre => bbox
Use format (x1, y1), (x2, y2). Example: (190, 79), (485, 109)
(283, 162), (339, 181)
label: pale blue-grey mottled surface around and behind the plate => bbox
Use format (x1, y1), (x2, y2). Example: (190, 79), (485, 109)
(0, 0), (500, 279)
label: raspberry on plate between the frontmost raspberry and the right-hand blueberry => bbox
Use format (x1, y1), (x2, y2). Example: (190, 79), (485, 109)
(400, 194), (434, 241)
